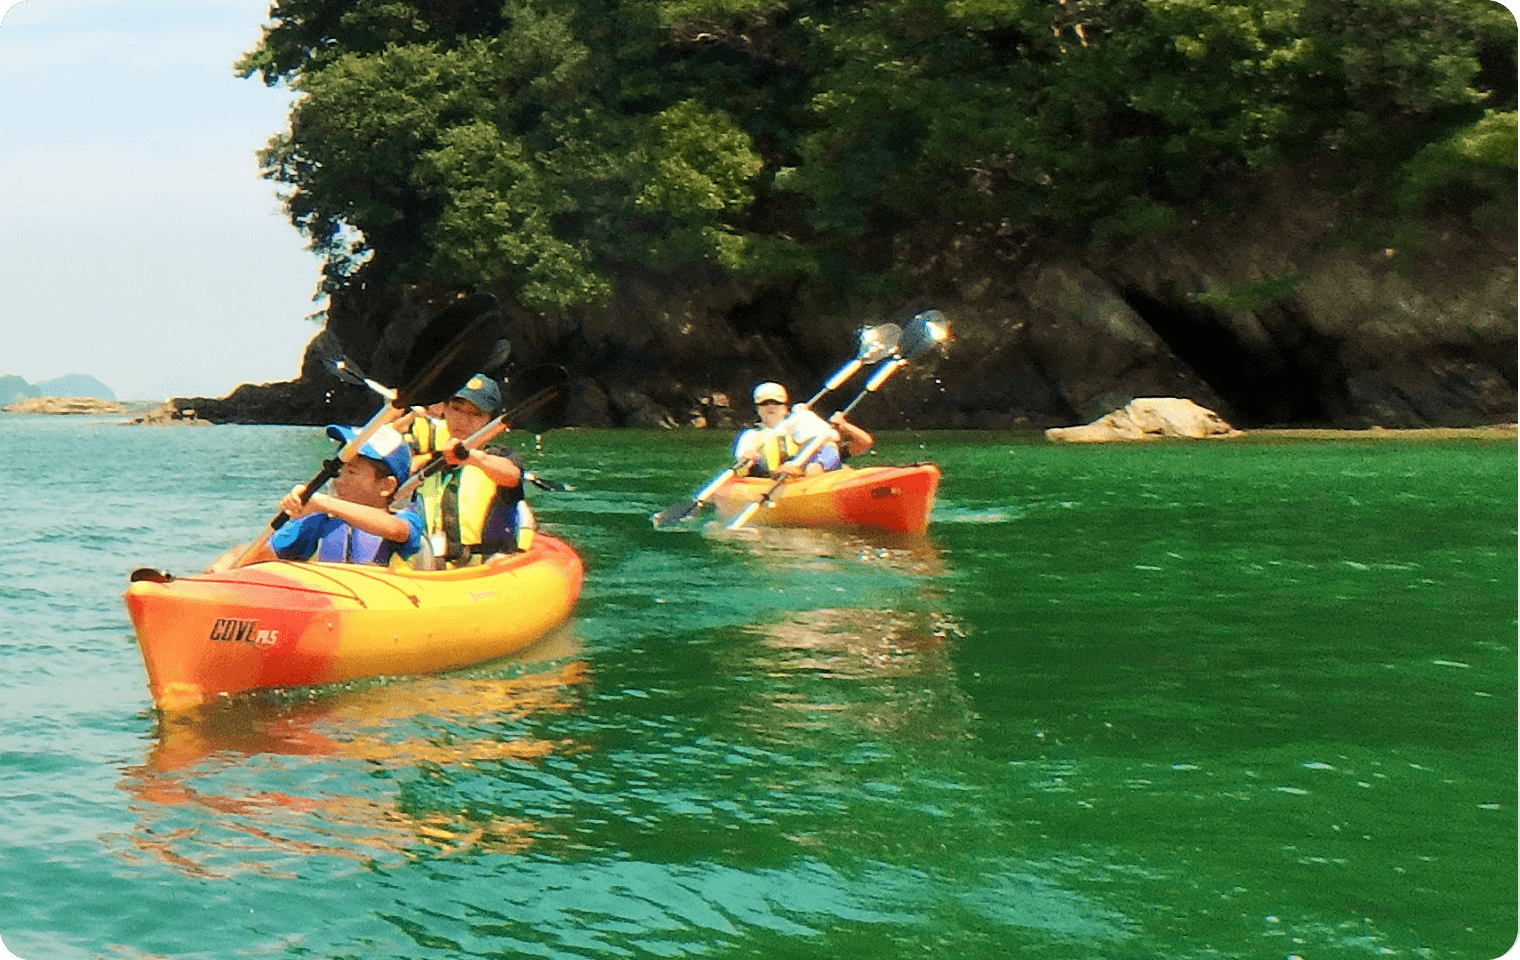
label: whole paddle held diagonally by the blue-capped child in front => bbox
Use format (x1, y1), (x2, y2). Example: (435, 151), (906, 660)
(218, 293), (500, 576)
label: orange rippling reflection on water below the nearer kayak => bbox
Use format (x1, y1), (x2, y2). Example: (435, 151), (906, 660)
(106, 630), (588, 878)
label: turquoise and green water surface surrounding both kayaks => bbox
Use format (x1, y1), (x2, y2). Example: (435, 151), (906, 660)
(0, 415), (1520, 960)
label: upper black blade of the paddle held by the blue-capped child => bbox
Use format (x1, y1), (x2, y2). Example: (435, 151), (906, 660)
(392, 293), (502, 407)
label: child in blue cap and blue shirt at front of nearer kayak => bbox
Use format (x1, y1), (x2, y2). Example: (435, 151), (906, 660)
(237, 424), (423, 565)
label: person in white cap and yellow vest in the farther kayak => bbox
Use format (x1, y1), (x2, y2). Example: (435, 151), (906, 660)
(734, 381), (874, 477)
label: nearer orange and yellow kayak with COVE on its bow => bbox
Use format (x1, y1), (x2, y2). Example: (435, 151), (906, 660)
(126, 533), (584, 711)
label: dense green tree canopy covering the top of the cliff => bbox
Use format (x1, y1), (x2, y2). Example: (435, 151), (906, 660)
(239, 0), (1517, 310)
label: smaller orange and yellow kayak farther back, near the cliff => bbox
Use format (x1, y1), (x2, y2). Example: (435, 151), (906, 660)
(713, 463), (939, 533)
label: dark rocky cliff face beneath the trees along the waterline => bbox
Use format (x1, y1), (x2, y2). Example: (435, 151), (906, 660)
(175, 175), (1520, 428)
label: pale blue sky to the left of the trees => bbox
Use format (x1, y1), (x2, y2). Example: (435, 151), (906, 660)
(0, 0), (328, 399)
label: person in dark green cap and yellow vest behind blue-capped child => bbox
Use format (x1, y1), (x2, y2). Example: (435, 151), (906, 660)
(418, 374), (534, 567)
